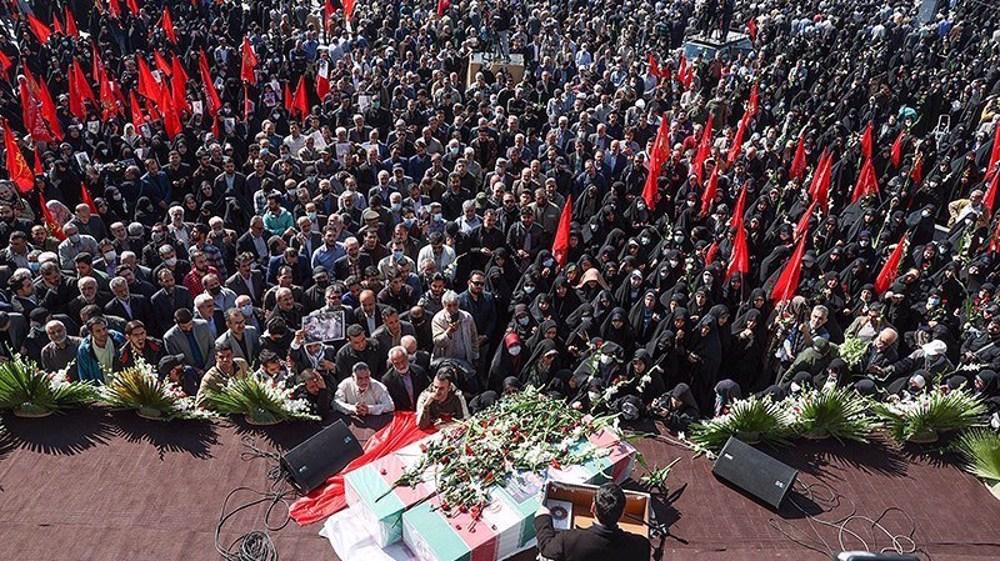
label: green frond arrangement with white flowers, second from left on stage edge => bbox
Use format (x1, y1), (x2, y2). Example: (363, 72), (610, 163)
(100, 357), (215, 421)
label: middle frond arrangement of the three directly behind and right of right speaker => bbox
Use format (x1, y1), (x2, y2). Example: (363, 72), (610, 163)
(792, 386), (879, 444)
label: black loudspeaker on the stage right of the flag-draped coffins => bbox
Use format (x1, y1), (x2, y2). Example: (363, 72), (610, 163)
(712, 437), (799, 510)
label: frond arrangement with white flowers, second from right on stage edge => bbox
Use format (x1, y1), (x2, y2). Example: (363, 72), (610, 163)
(874, 388), (986, 443)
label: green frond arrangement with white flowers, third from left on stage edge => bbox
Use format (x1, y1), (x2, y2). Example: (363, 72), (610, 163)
(204, 375), (320, 425)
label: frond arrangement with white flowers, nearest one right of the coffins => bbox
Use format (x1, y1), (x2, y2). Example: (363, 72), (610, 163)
(687, 396), (793, 456)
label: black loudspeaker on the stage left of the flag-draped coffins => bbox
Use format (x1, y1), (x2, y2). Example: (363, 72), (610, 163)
(281, 421), (364, 495)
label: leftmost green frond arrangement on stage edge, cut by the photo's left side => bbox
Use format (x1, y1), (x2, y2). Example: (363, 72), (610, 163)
(0, 355), (97, 417)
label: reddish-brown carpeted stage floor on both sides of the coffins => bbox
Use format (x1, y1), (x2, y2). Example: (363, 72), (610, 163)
(0, 410), (1000, 561)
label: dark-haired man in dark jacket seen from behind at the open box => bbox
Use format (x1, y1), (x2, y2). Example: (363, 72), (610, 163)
(535, 483), (649, 561)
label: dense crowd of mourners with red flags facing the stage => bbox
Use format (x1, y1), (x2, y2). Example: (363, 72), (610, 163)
(0, 0), (1000, 428)
